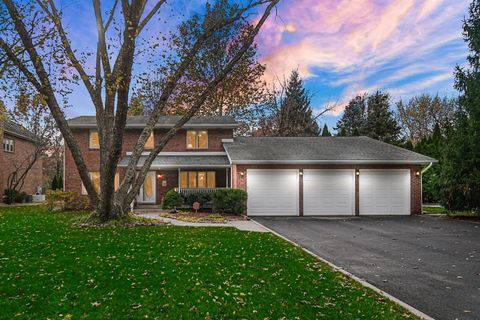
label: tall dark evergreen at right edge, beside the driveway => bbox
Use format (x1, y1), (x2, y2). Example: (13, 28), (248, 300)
(441, 0), (480, 210)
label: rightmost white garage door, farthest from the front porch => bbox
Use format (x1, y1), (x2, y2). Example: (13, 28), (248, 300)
(359, 170), (410, 215)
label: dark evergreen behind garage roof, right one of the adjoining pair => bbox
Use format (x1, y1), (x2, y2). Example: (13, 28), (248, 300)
(362, 91), (400, 143)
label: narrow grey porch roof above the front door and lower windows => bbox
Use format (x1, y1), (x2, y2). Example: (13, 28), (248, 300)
(118, 155), (230, 169)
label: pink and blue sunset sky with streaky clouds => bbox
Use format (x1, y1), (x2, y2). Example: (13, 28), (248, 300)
(57, 0), (469, 128)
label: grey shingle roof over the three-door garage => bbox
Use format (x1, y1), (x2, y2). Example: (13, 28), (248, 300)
(224, 137), (436, 164)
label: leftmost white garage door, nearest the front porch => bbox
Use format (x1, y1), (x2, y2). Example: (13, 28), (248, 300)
(247, 169), (299, 216)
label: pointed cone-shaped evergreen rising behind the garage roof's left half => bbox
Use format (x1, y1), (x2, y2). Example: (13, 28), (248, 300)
(275, 70), (320, 137)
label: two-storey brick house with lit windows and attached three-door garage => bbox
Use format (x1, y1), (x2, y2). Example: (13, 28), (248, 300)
(64, 116), (436, 216)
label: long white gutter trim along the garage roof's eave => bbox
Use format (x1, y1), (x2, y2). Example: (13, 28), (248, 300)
(231, 160), (437, 164)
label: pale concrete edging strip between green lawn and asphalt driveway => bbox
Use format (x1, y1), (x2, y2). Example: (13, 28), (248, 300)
(250, 219), (435, 320)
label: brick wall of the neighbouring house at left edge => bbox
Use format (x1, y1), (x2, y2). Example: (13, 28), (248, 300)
(0, 130), (43, 199)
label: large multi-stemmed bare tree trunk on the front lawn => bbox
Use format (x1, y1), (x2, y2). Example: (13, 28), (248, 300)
(0, 0), (279, 222)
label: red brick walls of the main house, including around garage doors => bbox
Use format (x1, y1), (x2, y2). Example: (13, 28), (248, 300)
(64, 125), (422, 215)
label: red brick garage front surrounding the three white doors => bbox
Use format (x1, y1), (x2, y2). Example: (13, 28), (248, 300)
(232, 164), (422, 215)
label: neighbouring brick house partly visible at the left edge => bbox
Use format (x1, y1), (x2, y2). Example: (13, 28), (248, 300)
(0, 120), (43, 197)
